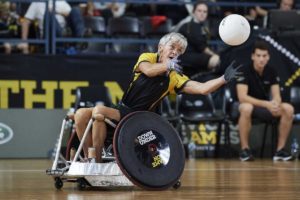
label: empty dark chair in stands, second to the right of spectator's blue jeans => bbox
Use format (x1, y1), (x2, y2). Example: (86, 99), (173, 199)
(107, 17), (142, 53)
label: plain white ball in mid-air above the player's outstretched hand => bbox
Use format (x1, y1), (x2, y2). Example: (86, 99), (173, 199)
(219, 14), (250, 46)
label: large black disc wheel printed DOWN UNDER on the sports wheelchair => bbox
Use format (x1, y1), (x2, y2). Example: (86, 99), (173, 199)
(114, 111), (185, 190)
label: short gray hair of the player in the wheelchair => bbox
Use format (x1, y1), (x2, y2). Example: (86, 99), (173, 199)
(158, 32), (187, 54)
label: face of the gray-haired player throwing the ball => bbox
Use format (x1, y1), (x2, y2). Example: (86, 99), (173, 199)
(158, 43), (182, 62)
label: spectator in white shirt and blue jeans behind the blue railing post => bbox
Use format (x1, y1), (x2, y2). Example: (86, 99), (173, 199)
(18, 0), (85, 54)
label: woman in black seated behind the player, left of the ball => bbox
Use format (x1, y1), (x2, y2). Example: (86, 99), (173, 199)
(178, 1), (220, 76)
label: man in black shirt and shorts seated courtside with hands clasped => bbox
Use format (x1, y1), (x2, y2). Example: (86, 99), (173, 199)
(236, 41), (294, 161)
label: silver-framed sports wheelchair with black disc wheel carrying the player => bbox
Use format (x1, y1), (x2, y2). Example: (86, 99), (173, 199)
(46, 87), (185, 190)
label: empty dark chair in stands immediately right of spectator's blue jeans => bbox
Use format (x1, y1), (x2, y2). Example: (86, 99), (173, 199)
(82, 16), (108, 54)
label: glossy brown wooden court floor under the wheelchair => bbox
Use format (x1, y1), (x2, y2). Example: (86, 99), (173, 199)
(0, 159), (300, 200)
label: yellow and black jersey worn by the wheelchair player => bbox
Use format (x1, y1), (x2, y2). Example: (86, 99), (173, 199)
(122, 53), (189, 111)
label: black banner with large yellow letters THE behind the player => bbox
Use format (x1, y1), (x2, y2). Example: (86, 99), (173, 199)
(0, 55), (137, 109)
